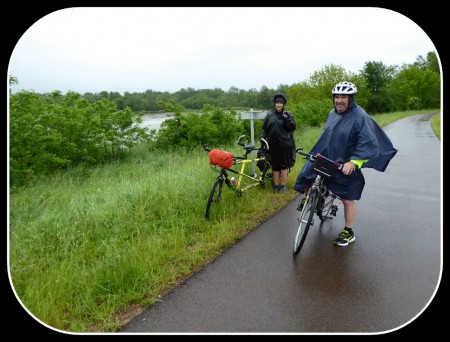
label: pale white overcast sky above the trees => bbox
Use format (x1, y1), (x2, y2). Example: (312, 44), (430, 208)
(9, 7), (437, 94)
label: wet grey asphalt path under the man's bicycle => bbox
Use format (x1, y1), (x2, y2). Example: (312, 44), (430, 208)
(119, 115), (443, 334)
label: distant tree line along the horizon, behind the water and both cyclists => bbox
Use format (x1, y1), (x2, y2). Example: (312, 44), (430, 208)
(72, 52), (440, 114)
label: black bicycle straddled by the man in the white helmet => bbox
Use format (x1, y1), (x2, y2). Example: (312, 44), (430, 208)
(294, 147), (343, 255)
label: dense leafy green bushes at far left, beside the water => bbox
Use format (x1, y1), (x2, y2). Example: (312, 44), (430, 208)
(10, 91), (147, 184)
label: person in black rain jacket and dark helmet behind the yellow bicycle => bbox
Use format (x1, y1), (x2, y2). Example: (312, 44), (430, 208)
(261, 93), (297, 193)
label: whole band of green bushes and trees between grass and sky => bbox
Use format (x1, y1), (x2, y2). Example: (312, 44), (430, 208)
(9, 52), (441, 185)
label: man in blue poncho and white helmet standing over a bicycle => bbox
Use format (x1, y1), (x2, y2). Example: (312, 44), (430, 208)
(294, 82), (397, 246)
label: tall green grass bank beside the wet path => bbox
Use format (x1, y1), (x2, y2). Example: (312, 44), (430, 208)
(9, 111), (439, 332)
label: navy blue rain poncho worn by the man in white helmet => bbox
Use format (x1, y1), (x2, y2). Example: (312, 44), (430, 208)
(294, 101), (398, 200)
